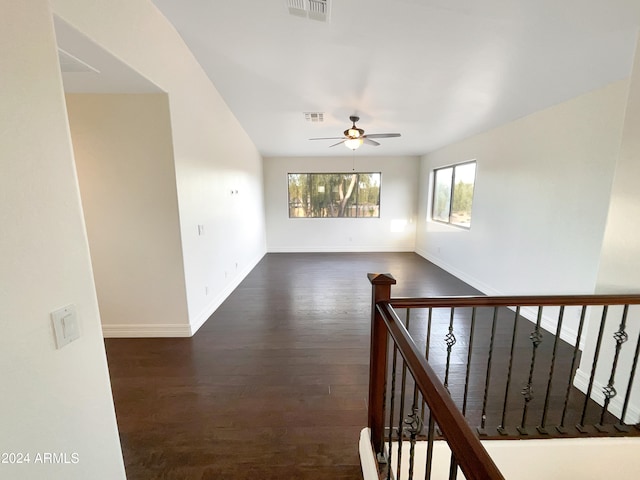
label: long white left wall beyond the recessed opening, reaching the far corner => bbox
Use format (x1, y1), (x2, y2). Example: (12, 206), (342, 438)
(52, 0), (266, 331)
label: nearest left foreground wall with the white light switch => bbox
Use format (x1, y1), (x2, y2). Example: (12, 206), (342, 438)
(0, 0), (125, 480)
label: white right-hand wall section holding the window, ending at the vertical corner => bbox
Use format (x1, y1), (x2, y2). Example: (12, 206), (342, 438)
(416, 81), (628, 341)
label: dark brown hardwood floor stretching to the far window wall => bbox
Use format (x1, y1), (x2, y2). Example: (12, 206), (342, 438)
(105, 253), (608, 480)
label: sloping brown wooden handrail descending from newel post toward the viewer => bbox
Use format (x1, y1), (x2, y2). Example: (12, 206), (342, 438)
(376, 301), (504, 480)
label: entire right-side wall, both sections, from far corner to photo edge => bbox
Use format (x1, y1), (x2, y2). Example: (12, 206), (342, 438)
(417, 33), (640, 422)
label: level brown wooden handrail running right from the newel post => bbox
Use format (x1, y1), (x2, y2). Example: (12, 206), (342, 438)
(390, 294), (640, 308)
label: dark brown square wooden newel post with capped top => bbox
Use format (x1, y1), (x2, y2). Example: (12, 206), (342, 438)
(367, 273), (396, 453)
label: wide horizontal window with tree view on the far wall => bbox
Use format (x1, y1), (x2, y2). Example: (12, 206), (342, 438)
(289, 173), (381, 218)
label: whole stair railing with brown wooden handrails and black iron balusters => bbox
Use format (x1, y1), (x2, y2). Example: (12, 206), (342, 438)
(368, 274), (640, 479)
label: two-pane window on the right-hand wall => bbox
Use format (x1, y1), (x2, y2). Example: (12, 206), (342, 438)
(431, 161), (476, 228)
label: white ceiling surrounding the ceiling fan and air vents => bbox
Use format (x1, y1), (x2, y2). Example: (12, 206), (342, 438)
(60, 0), (640, 156)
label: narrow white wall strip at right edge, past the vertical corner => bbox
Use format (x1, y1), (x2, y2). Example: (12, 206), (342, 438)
(578, 37), (640, 422)
